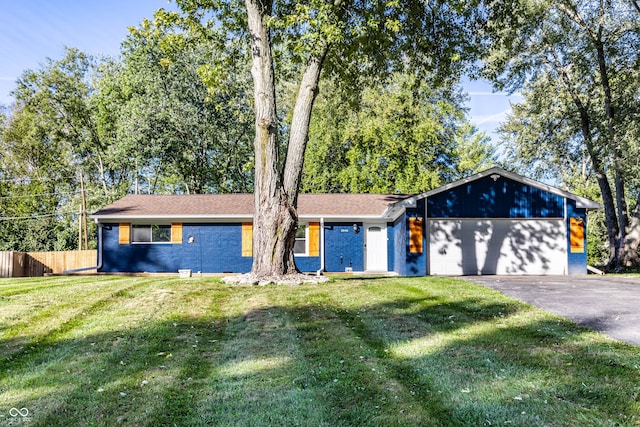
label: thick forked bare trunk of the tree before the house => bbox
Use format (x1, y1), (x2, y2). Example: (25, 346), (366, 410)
(245, 0), (332, 277)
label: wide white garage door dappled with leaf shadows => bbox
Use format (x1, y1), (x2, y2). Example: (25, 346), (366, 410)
(428, 219), (567, 275)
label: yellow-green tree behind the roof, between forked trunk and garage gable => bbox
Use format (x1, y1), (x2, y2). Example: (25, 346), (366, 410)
(302, 75), (493, 193)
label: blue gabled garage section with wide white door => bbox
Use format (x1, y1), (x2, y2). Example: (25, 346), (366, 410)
(405, 168), (601, 276)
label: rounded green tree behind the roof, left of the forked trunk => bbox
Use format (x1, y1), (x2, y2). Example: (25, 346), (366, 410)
(97, 19), (253, 193)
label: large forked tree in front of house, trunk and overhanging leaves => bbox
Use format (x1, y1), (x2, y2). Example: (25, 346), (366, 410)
(170, 0), (482, 277)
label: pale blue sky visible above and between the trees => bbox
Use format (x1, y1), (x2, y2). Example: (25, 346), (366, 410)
(0, 0), (520, 142)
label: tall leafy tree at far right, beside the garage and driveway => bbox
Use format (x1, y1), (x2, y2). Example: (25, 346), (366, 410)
(485, 0), (640, 268)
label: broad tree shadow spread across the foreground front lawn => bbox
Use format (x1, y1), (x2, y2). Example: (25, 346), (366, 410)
(0, 288), (638, 426)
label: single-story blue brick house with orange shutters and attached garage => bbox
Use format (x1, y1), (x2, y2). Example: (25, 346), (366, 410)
(92, 168), (600, 276)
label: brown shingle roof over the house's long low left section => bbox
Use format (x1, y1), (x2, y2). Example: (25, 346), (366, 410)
(92, 194), (408, 219)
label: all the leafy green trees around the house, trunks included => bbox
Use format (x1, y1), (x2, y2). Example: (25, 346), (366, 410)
(11, 0), (640, 275)
